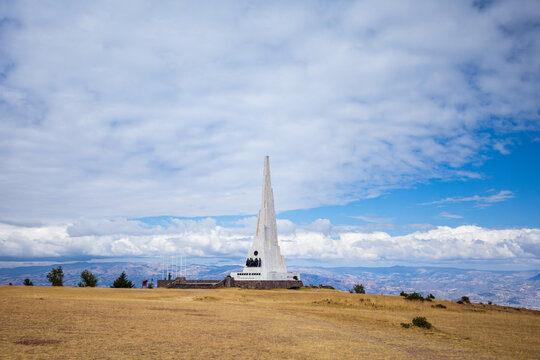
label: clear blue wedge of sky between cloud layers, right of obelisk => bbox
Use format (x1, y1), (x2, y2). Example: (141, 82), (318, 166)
(279, 136), (540, 228)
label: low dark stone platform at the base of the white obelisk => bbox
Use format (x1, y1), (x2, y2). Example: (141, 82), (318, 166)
(158, 276), (304, 289)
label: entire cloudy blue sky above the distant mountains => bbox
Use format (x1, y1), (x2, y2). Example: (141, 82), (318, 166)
(0, 1), (540, 268)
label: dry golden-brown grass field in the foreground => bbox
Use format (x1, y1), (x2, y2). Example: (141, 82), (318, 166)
(0, 286), (540, 359)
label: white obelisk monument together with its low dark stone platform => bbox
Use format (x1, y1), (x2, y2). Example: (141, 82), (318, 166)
(158, 156), (303, 289)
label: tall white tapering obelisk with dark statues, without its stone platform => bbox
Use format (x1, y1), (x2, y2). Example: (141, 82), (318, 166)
(231, 156), (300, 280)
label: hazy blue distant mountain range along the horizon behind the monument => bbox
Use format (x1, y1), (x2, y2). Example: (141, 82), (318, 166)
(0, 262), (540, 309)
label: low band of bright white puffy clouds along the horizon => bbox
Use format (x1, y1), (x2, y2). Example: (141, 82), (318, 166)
(0, 218), (540, 262)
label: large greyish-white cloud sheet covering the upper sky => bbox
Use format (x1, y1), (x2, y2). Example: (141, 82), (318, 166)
(0, 0), (540, 222)
